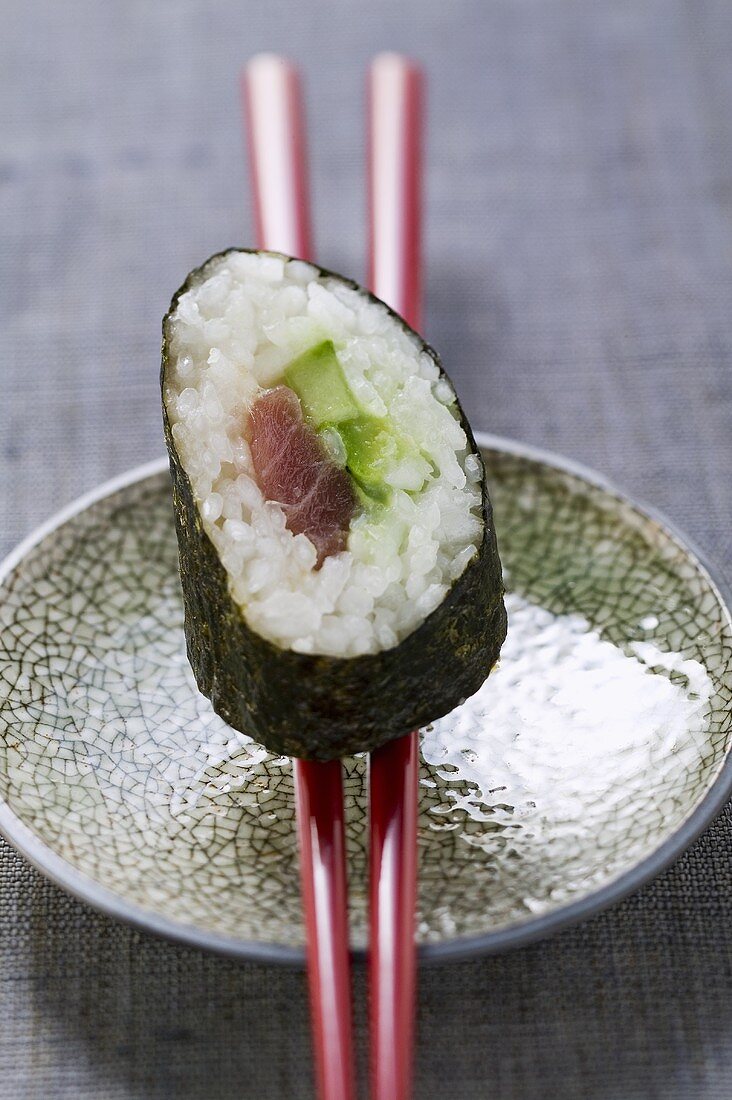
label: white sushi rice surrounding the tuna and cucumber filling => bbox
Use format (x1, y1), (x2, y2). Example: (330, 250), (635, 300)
(165, 252), (483, 657)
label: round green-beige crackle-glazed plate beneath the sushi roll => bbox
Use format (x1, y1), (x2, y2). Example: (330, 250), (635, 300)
(0, 437), (732, 961)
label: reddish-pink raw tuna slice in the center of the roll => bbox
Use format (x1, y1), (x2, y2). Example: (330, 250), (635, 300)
(249, 386), (356, 567)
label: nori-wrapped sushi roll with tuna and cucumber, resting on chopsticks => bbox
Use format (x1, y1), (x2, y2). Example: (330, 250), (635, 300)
(161, 250), (506, 760)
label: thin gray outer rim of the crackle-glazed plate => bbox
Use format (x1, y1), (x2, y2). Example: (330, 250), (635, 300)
(0, 431), (732, 967)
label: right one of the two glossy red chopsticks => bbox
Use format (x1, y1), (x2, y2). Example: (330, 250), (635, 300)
(368, 54), (423, 1100)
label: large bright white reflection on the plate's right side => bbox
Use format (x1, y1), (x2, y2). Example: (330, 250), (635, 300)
(422, 595), (712, 912)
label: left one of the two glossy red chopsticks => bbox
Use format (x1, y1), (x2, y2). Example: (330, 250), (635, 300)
(242, 54), (354, 1100)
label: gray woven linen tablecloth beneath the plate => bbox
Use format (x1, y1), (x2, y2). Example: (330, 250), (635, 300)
(0, 0), (732, 1100)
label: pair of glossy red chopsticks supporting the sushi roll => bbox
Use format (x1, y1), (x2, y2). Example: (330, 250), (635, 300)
(242, 54), (422, 1100)
